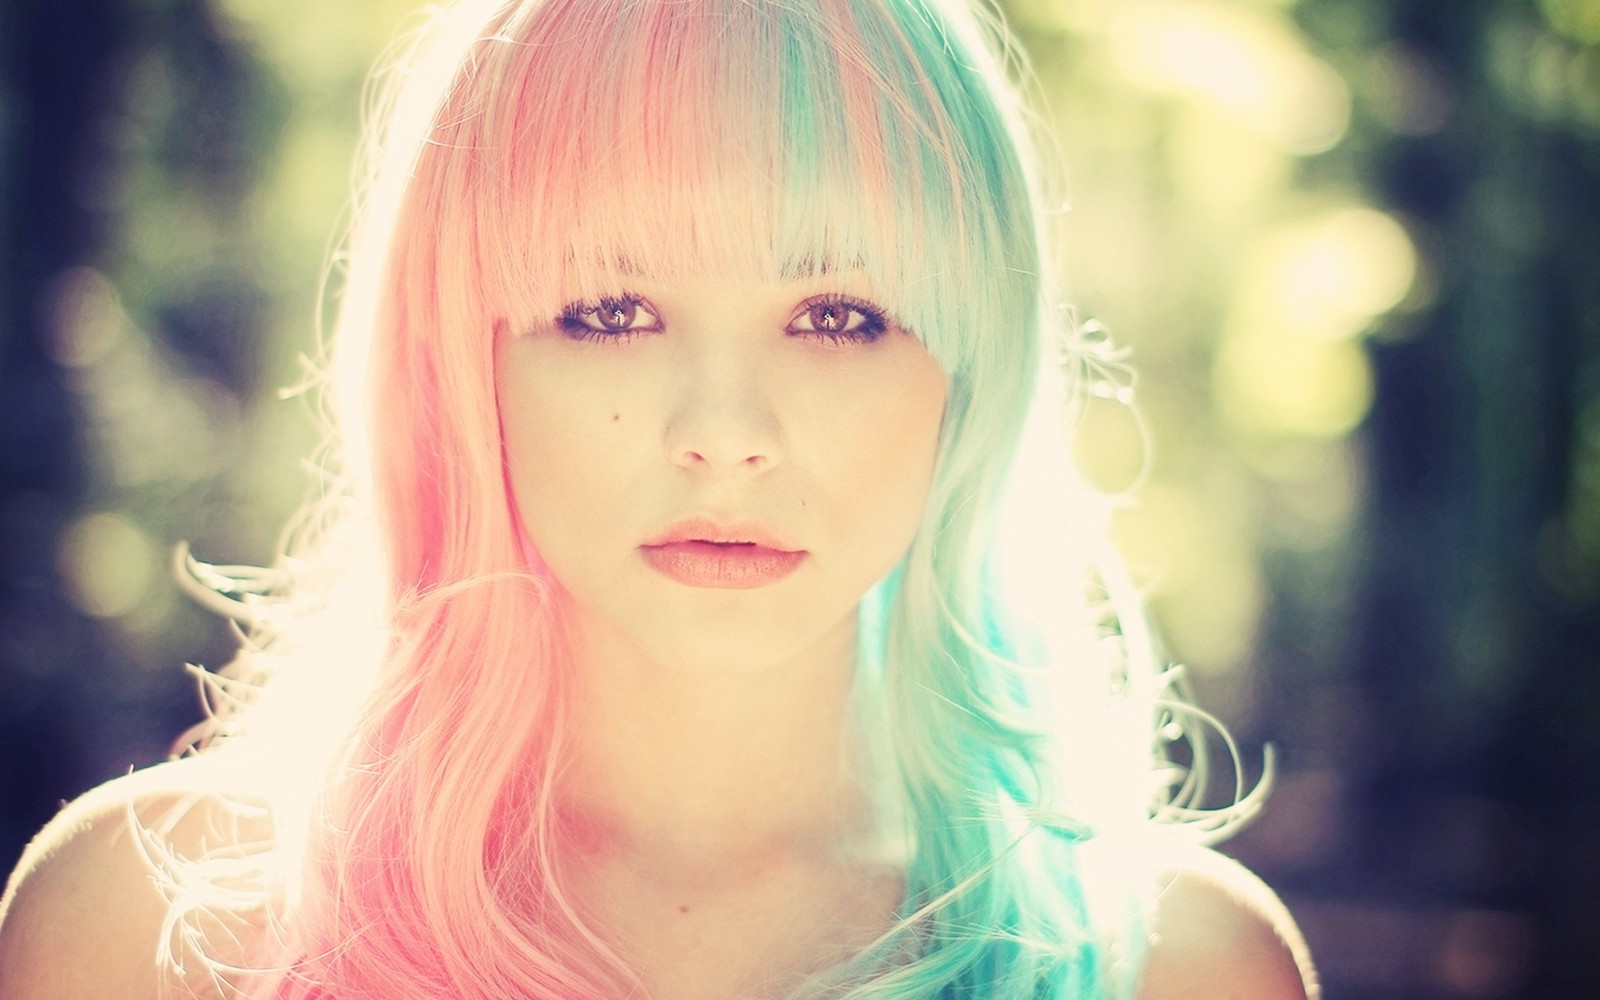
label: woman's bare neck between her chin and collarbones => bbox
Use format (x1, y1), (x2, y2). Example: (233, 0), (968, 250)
(558, 601), (872, 870)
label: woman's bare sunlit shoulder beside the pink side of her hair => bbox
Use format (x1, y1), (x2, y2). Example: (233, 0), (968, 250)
(0, 762), (269, 1000)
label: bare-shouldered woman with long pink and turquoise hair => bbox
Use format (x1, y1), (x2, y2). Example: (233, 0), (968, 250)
(0, 0), (1315, 1000)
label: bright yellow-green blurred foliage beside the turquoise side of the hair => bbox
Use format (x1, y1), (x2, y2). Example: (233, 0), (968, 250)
(1008, 0), (1401, 697)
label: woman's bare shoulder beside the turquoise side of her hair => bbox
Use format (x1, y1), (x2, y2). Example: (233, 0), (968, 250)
(1138, 846), (1320, 1000)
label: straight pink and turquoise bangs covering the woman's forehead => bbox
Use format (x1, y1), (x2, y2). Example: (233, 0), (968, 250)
(440, 0), (1040, 382)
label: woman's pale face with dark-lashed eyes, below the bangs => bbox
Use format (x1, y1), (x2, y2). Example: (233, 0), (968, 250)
(496, 274), (946, 669)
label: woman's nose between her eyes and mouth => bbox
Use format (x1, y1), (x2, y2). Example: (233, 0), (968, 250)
(666, 352), (782, 474)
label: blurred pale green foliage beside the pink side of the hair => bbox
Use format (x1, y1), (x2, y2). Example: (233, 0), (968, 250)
(48, 0), (414, 670)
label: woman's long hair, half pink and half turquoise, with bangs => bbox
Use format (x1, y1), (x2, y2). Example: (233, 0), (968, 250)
(152, 0), (1248, 1000)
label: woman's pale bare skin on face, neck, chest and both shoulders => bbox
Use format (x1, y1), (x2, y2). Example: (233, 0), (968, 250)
(0, 277), (1317, 1000)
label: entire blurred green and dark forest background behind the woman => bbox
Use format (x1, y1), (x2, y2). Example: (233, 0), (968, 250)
(0, 0), (1600, 1000)
